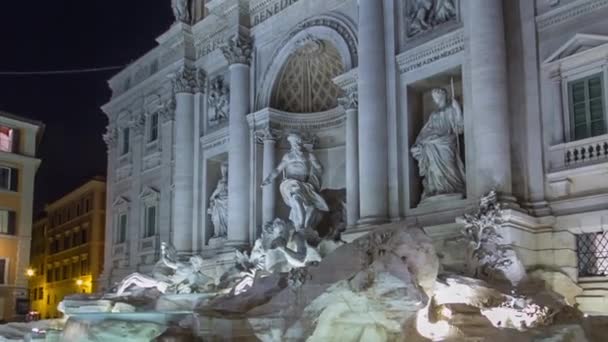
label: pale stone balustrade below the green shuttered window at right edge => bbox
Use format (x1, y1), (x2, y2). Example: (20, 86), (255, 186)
(549, 134), (608, 171)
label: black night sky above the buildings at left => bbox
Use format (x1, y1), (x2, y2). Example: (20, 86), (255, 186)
(0, 0), (173, 210)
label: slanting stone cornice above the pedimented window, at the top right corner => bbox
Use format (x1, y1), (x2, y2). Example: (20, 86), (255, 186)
(536, 0), (608, 32)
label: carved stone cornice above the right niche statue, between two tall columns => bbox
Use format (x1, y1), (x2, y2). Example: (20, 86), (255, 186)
(397, 29), (464, 74)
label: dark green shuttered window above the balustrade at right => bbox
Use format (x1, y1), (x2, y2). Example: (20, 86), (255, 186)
(568, 74), (606, 140)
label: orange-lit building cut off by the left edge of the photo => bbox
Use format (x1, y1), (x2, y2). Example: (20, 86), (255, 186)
(0, 111), (44, 321)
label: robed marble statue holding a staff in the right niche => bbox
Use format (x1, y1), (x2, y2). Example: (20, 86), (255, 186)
(411, 88), (465, 201)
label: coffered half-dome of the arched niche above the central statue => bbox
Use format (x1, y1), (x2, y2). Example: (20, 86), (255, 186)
(270, 36), (345, 113)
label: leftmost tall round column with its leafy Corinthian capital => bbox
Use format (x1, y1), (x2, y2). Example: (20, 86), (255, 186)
(172, 66), (198, 252)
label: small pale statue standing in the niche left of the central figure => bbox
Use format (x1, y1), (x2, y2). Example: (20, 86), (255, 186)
(207, 163), (228, 238)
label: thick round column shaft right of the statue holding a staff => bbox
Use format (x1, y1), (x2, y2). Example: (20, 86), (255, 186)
(465, 0), (512, 197)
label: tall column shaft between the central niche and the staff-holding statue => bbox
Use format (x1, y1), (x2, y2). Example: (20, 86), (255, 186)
(358, 0), (388, 224)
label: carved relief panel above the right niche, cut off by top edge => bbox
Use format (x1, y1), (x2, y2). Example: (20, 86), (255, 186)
(407, 0), (456, 37)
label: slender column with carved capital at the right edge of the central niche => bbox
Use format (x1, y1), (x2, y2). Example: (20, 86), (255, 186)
(339, 88), (359, 227)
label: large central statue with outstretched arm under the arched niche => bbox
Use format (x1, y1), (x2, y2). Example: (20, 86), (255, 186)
(262, 134), (329, 230)
